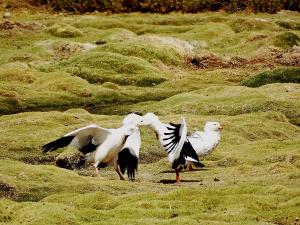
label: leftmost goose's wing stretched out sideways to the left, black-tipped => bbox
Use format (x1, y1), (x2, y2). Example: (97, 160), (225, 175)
(42, 124), (111, 154)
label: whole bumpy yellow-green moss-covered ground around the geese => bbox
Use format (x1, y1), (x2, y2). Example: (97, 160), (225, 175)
(0, 10), (300, 225)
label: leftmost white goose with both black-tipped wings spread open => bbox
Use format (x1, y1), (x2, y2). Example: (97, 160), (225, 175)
(42, 113), (143, 180)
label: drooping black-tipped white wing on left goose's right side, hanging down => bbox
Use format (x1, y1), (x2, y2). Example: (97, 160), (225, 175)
(118, 130), (141, 181)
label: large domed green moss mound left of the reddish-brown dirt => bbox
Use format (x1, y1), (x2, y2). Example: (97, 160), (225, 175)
(56, 52), (166, 86)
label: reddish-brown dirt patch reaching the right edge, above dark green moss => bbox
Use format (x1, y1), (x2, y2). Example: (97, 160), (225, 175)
(186, 46), (300, 69)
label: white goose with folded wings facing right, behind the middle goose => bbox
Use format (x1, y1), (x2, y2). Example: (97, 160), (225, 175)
(187, 122), (223, 170)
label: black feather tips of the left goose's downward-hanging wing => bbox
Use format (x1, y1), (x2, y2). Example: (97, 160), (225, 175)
(118, 148), (138, 181)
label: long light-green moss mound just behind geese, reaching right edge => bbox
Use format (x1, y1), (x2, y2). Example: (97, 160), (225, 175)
(136, 84), (300, 124)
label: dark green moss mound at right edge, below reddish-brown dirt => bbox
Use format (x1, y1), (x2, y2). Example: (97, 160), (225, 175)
(241, 67), (300, 87)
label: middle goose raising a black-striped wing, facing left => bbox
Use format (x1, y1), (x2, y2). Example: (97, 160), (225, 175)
(144, 113), (202, 183)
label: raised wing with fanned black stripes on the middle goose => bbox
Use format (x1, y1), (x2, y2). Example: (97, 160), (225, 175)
(161, 117), (187, 163)
